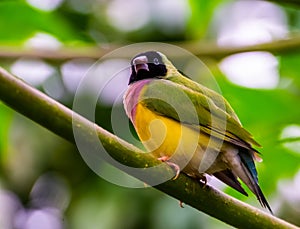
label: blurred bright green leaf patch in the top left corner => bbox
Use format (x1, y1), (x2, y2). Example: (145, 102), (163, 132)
(0, 1), (79, 44)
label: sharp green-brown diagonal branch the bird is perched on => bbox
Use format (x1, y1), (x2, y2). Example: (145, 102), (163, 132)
(0, 68), (297, 229)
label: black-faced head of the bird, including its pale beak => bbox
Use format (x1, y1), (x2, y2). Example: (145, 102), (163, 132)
(129, 51), (167, 84)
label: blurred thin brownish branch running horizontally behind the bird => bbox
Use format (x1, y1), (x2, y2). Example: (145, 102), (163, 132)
(0, 35), (300, 61)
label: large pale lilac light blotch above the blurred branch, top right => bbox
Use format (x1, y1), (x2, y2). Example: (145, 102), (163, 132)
(215, 0), (288, 46)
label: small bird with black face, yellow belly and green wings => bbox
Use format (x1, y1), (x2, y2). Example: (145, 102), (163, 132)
(124, 51), (272, 213)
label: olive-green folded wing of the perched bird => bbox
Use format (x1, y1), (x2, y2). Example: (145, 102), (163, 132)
(140, 76), (260, 148)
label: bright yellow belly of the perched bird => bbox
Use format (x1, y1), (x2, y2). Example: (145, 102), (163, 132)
(134, 104), (204, 168)
